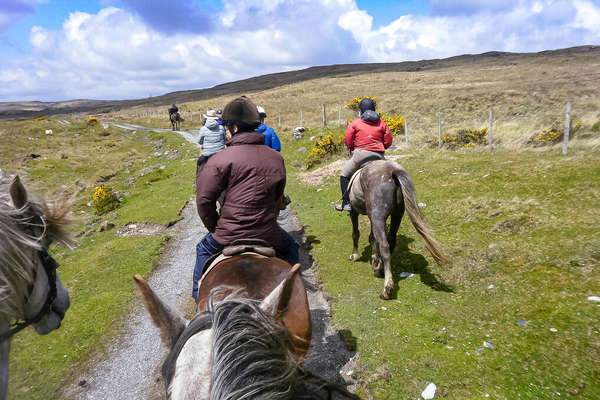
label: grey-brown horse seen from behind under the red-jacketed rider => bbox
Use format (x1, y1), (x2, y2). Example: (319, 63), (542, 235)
(350, 160), (450, 300)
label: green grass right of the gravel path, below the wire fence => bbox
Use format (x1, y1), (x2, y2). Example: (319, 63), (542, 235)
(284, 130), (600, 399)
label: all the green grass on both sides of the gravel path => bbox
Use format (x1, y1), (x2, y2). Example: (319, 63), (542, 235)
(0, 115), (600, 399)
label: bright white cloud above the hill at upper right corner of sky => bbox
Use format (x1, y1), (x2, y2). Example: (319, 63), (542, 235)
(340, 0), (600, 62)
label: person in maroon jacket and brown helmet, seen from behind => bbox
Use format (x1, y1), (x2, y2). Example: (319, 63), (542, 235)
(192, 96), (299, 299)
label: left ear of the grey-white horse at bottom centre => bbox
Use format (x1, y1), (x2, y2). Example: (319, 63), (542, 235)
(133, 274), (189, 349)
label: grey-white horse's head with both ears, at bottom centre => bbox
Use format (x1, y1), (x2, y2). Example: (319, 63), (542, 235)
(134, 262), (359, 400)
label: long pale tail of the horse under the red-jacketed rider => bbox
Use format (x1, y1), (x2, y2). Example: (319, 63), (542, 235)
(392, 168), (450, 264)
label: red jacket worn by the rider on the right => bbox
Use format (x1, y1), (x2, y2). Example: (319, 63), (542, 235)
(345, 118), (392, 152)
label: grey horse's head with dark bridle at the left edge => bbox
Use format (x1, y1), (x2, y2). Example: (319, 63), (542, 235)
(0, 176), (71, 400)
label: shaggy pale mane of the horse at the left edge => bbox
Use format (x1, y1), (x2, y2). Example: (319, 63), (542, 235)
(0, 179), (71, 319)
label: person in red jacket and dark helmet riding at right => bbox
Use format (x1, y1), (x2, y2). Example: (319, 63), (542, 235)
(335, 98), (392, 211)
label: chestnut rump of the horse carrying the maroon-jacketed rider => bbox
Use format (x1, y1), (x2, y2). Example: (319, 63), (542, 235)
(197, 254), (312, 355)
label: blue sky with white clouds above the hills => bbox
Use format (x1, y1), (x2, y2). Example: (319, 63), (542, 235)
(0, 0), (600, 102)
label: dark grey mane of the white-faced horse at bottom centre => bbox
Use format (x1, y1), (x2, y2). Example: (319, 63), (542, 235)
(163, 293), (359, 400)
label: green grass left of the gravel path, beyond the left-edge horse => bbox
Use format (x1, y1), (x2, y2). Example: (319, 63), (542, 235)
(0, 120), (197, 400)
